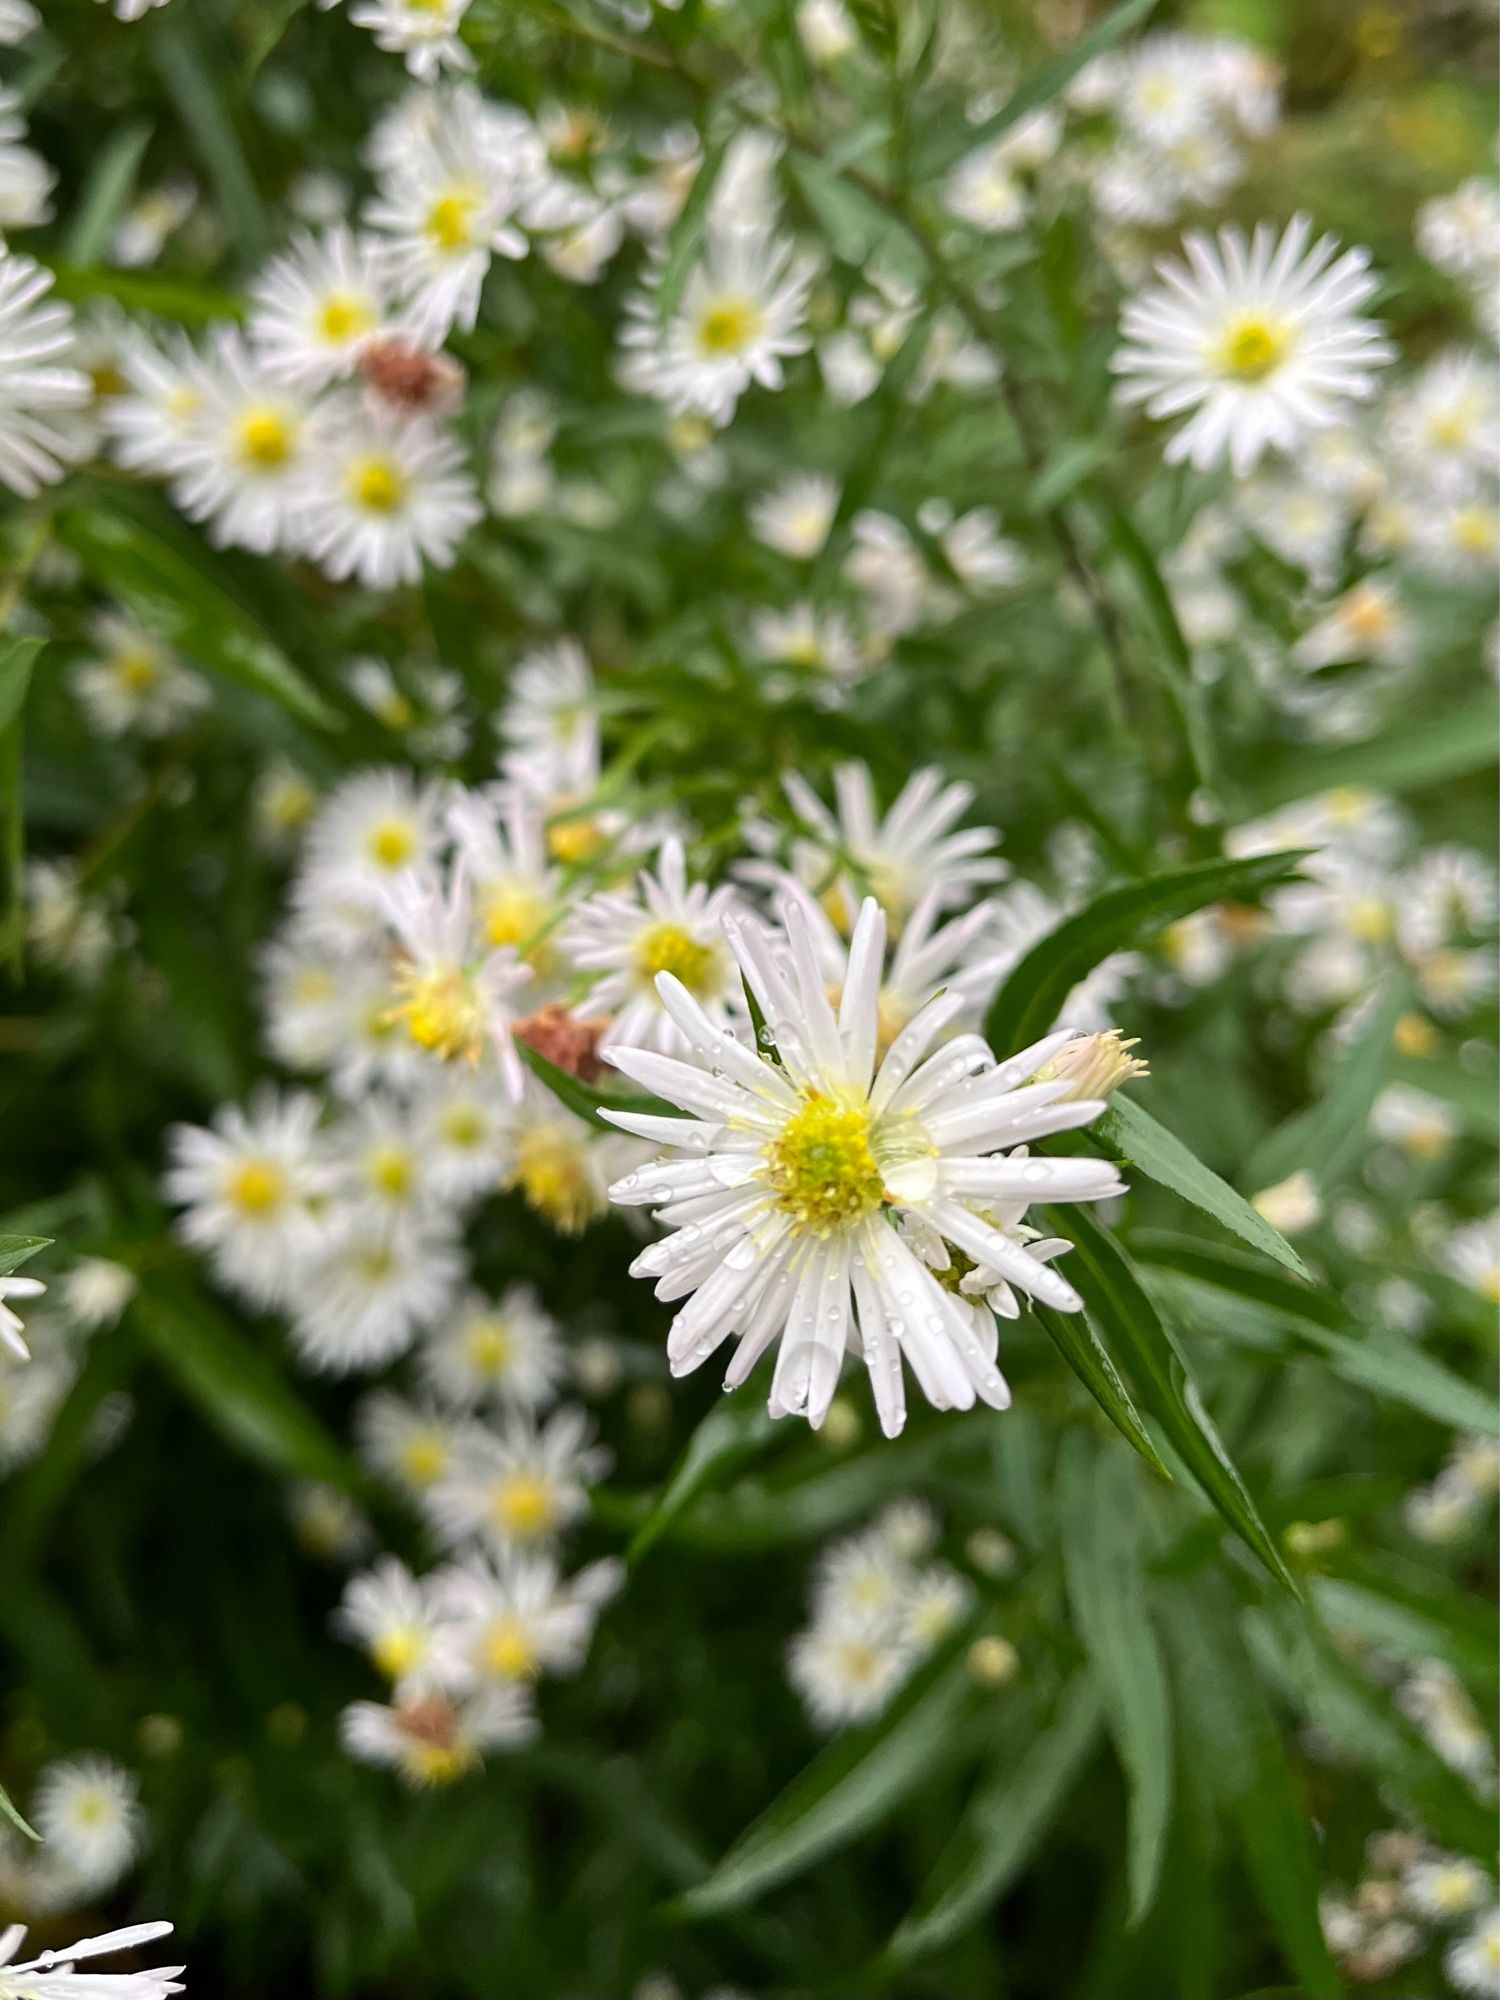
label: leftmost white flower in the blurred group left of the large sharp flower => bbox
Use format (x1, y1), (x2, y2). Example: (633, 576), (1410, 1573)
(164, 1084), (330, 1306)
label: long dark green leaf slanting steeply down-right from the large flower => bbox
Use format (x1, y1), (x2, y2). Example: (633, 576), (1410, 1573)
(1066, 1208), (1296, 1594)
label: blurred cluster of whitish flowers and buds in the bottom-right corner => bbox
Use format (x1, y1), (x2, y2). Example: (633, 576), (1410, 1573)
(1318, 1832), (1500, 2000)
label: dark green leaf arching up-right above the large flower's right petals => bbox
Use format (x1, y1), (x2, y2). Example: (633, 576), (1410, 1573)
(984, 850), (1304, 1056)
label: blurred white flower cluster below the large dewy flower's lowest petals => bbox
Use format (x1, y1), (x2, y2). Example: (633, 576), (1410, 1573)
(788, 1500), (968, 1728)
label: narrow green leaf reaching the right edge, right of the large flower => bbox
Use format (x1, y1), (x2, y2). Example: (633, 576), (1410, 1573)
(1134, 1230), (1500, 1432)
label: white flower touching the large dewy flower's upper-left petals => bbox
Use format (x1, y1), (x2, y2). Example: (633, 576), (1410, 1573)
(562, 838), (740, 1052)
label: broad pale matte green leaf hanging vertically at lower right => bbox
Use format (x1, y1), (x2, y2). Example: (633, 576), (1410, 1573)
(1058, 1432), (1172, 1924)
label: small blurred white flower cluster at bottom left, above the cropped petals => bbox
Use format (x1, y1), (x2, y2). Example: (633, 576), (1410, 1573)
(0, 1754), (142, 1912)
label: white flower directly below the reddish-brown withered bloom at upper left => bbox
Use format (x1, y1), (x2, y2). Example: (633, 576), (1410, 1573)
(298, 398), (484, 590)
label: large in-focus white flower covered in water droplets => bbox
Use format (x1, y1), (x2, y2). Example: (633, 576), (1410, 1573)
(608, 900), (1122, 1436)
